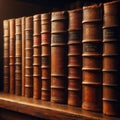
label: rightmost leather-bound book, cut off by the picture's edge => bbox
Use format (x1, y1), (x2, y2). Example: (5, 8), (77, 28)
(103, 1), (120, 116)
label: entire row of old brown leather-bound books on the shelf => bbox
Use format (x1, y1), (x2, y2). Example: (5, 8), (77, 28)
(3, 0), (120, 116)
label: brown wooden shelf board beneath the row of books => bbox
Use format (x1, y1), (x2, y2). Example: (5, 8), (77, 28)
(0, 92), (120, 120)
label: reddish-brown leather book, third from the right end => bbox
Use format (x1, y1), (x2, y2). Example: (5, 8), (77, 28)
(68, 8), (82, 106)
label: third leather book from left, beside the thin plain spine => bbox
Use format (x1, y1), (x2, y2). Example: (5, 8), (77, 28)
(15, 18), (22, 95)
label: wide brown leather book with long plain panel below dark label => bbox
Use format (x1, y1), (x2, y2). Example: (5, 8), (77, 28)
(51, 11), (67, 103)
